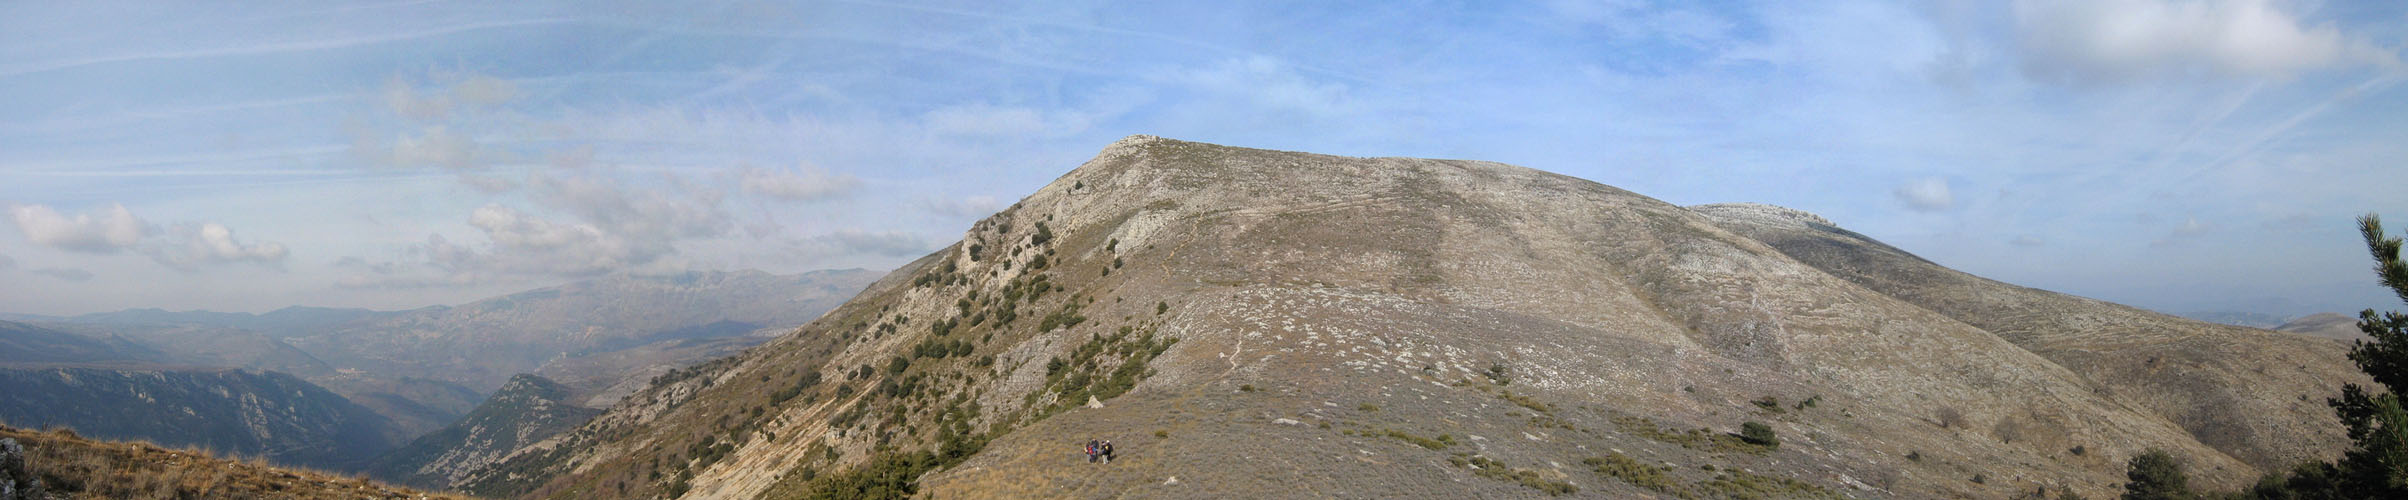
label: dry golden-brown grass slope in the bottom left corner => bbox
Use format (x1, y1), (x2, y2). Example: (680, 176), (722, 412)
(0, 425), (458, 498)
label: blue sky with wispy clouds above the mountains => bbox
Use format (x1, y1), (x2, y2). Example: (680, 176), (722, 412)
(0, 0), (2408, 315)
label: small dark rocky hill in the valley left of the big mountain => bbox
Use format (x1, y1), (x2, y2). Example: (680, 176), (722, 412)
(366, 375), (602, 490)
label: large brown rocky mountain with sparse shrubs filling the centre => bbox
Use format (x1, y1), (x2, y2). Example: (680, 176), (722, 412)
(460, 137), (2365, 498)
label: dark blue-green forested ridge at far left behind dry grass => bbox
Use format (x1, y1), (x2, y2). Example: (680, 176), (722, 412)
(0, 363), (400, 469)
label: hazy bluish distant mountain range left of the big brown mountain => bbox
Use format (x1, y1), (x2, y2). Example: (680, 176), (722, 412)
(0, 269), (877, 469)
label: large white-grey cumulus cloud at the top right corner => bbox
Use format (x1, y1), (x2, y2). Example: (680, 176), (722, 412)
(2015, 0), (2394, 82)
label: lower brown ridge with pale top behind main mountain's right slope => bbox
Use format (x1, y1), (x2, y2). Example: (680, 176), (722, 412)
(1695, 204), (2367, 469)
